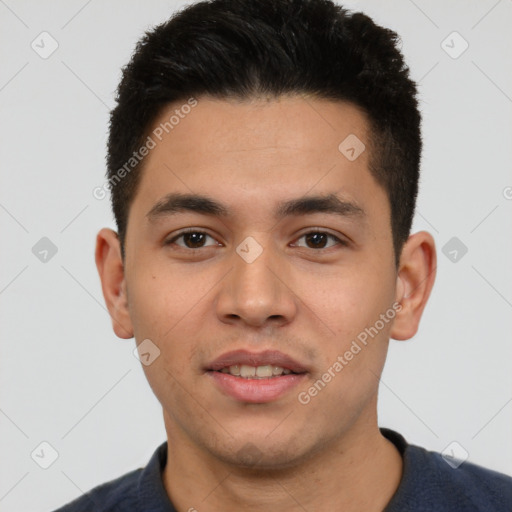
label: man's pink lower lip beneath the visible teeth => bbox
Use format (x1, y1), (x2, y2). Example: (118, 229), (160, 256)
(208, 371), (306, 404)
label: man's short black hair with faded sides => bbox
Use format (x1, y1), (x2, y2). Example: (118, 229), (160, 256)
(107, 0), (422, 262)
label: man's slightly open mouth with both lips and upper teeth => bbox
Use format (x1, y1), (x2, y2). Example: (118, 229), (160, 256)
(205, 350), (308, 403)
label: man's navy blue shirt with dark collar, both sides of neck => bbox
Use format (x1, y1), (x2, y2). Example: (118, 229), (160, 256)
(55, 428), (512, 512)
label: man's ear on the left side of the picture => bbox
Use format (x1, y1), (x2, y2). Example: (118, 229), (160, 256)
(95, 228), (133, 339)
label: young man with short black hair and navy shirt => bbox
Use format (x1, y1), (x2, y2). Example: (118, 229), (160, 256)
(53, 0), (512, 512)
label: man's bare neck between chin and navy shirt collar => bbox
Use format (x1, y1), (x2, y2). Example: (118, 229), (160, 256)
(163, 406), (402, 512)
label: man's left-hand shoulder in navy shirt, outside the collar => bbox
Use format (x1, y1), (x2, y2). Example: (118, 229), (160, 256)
(51, 469), (142, 512)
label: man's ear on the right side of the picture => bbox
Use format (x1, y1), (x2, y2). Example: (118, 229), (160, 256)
(390, 231), (437, 340)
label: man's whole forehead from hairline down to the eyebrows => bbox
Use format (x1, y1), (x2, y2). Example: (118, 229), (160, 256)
(128, 96), (383, 226)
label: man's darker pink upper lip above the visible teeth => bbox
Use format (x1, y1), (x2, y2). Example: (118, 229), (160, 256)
(207, 350), (307, 373)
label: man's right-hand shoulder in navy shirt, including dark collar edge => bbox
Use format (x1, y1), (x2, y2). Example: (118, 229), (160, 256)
(381, 429), (512, 512)
